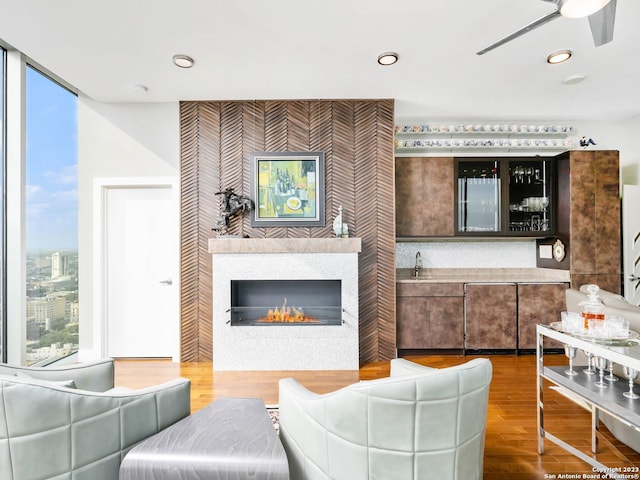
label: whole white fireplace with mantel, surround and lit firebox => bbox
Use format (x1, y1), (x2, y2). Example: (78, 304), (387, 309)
(209, 238), (362, 371)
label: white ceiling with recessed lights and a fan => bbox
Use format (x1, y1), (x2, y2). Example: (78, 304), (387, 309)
(0, 0), (640, 121)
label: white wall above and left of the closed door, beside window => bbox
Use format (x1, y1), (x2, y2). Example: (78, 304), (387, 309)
(78, 97), (180, 358)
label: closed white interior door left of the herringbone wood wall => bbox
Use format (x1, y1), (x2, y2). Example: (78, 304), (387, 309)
(104, 185), (179, 357)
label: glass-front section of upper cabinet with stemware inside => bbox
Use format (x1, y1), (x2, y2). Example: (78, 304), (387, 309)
(455, 157), (555, 237)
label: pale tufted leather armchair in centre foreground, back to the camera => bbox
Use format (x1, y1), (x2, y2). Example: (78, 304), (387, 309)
(280, 358), (492, 480)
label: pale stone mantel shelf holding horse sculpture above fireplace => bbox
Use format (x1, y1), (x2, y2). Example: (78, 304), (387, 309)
(209, 238), (362, 253)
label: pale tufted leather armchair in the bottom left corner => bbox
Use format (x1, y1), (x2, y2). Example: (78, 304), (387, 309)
(0, 359), (191, 480)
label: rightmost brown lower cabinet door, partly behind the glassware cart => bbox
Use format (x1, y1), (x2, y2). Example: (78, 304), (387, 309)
(518, 283), (569, 350)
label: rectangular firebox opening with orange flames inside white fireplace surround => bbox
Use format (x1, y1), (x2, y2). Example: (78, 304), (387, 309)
(230, 280), (342, 326)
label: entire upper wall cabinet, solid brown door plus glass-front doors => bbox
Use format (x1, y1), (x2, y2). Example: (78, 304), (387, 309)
(395, 157), (555, 238)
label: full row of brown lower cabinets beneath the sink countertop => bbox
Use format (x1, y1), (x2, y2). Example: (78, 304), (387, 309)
(396, 281), (569, 353)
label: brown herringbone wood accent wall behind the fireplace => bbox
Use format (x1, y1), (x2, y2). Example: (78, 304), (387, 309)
(180, 100), (396, 363)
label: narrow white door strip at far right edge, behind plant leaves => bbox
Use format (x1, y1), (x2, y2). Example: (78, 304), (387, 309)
(622, 185), (640, 305)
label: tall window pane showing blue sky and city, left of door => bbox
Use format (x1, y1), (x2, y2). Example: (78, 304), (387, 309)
(24, 67), (79, 364)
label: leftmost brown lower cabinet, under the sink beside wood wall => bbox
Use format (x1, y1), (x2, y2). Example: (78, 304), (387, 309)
(396, 282), (464, 350)
